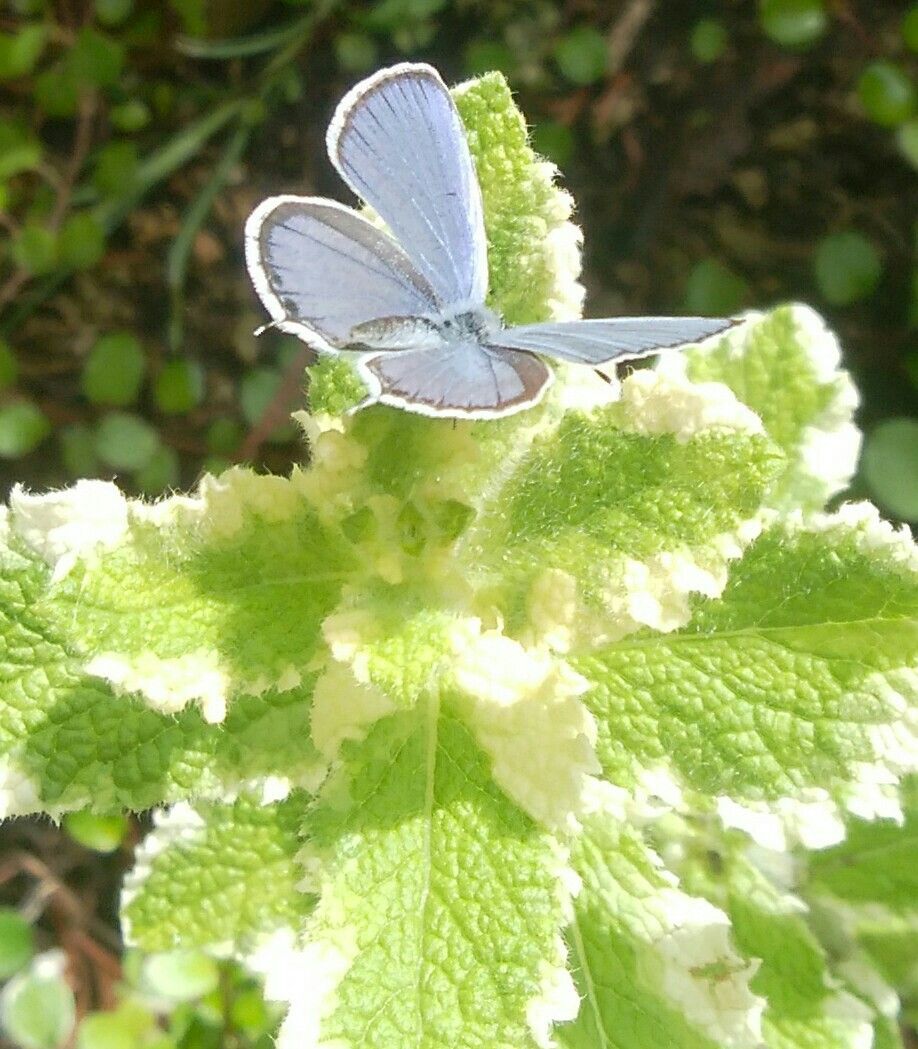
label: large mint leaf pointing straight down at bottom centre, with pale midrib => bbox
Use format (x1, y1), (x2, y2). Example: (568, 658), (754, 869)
(260, 694), (577, 1049)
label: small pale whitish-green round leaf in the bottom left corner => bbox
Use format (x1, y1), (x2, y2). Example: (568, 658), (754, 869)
(0, 951), (77, 1049)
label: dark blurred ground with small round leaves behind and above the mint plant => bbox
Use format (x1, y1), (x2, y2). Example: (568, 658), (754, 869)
(0, 0), (918, 517)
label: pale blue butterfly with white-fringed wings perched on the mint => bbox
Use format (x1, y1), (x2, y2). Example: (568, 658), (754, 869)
(245, 62), (734, 419)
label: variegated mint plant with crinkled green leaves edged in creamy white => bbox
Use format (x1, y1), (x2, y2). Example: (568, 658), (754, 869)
(0, 74), (918, 1049)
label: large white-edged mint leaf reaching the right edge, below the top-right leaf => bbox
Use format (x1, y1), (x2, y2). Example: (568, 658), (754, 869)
(574, 506), (918, 830)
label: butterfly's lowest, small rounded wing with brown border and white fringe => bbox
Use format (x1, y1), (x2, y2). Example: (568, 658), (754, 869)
(359, 339), (552, 419)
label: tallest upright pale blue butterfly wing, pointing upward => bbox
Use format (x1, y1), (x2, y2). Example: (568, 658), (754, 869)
(327, 62), (488, 306)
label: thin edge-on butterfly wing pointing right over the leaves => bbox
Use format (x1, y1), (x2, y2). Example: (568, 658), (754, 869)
(492, 317), (736, 365)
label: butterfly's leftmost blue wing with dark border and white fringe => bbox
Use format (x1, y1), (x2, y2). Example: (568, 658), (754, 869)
(245, 196), (436, 349)
